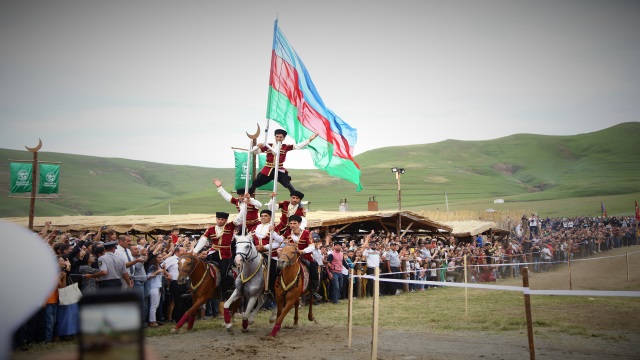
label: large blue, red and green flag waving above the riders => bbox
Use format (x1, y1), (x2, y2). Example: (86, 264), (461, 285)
(267, 19), (362, 191)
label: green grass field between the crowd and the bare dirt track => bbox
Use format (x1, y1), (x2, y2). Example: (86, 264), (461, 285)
(15, 246), (640, 359)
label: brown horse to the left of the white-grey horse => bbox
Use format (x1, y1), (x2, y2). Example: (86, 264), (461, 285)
(171, 253), (222, 333)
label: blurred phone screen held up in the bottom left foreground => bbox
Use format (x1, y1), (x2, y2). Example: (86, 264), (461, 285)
(80, 302), (142, 360)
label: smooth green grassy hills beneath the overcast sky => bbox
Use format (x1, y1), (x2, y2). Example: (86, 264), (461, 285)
(0, 122), (640, 217)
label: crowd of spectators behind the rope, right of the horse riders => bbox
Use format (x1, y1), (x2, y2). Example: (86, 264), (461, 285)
(312, 214), (639, 301)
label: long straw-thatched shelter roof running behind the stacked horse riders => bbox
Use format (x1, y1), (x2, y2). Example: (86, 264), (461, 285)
(2, 211), (451, 234)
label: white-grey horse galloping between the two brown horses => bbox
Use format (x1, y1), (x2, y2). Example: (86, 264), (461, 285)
(224, 234), (276, 332)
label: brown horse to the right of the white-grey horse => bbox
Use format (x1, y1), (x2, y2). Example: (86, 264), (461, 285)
(266, 244), (316, 339)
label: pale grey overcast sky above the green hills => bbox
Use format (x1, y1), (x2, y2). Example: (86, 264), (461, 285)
(0, 0), (640, 168)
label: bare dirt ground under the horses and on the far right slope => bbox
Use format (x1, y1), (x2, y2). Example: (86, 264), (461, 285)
(13, 246), (640, 360)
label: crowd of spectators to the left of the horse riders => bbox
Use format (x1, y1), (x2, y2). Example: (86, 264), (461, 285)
(13, 222), (202, 348)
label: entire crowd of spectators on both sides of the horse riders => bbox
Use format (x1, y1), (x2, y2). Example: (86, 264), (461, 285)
(14, 216), (638, 347)
